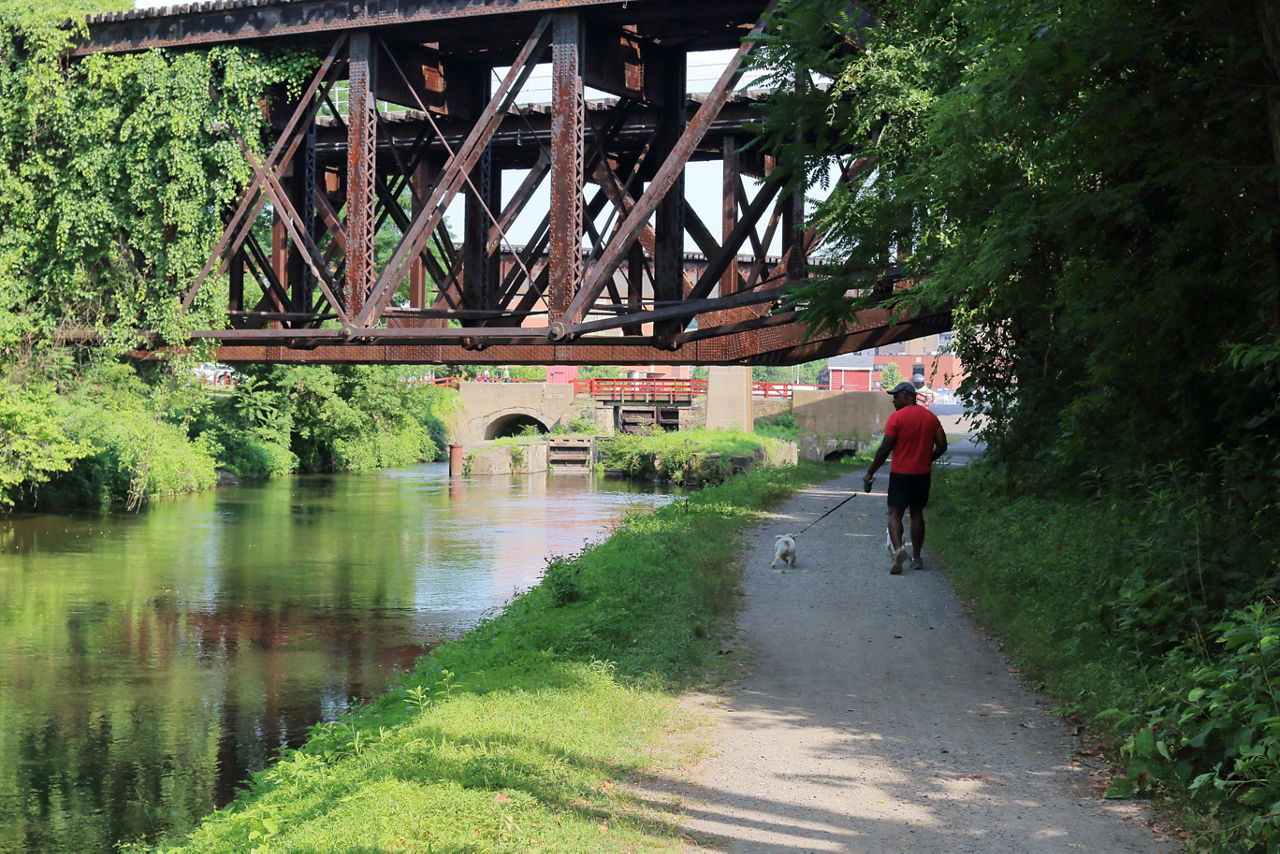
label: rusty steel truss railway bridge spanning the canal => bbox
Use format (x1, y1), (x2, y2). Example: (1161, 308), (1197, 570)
(76, 0), (951, 364)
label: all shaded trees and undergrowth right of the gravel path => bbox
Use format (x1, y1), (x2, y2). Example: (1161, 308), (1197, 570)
(760, 0), (1280, 850)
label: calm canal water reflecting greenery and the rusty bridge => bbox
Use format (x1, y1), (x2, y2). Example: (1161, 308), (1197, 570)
(0, 463), (668, 851)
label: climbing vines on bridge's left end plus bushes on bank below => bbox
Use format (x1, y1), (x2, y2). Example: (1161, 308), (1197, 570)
(0, 0), (460, 508)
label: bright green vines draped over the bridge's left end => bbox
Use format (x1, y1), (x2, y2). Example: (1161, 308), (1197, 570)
(0, 10), (317, 361)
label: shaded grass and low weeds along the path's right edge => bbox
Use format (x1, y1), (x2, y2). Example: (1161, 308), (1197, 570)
(929, 467), (1280, 851)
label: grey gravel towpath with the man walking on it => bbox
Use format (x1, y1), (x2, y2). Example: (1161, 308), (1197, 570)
(637, 471), (1181, 853)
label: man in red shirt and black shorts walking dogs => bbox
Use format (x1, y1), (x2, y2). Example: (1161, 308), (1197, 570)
(863, 383), (947, 575)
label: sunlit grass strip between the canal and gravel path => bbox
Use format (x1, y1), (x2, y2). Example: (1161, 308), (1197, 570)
(147, 465), (837, 851)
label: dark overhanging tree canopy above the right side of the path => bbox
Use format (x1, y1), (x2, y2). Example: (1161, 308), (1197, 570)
(760, 0), (1280, 483)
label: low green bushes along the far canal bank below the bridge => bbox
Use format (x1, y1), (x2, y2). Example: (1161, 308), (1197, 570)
(0, 362), (456, 508)
